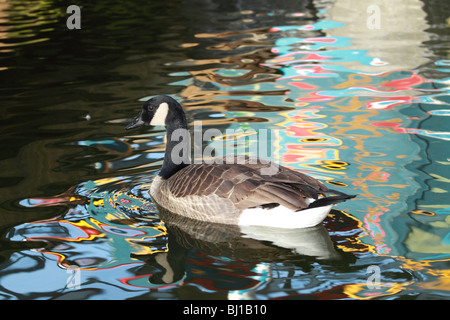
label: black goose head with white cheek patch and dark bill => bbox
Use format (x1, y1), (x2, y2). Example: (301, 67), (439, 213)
(125, 95), (187, 130)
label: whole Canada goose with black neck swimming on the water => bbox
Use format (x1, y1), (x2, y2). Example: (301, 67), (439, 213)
(126, 95), (355, 228)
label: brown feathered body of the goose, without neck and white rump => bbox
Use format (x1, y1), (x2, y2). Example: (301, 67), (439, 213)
(150, 157), (347, 224)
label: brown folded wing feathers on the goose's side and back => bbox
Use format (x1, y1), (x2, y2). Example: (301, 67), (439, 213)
(163, 158), (329, 210)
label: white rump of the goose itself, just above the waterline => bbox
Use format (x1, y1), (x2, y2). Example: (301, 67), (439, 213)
(238, 204), (333, 229)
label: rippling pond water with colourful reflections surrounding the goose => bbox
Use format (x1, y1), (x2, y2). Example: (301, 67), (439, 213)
(0, 0), (450, 300)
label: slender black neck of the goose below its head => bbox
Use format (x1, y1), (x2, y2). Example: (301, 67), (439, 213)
(159, 114), (191, 179)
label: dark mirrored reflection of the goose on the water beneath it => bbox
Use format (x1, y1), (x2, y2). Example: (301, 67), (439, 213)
(133, 207), (351, 289)
